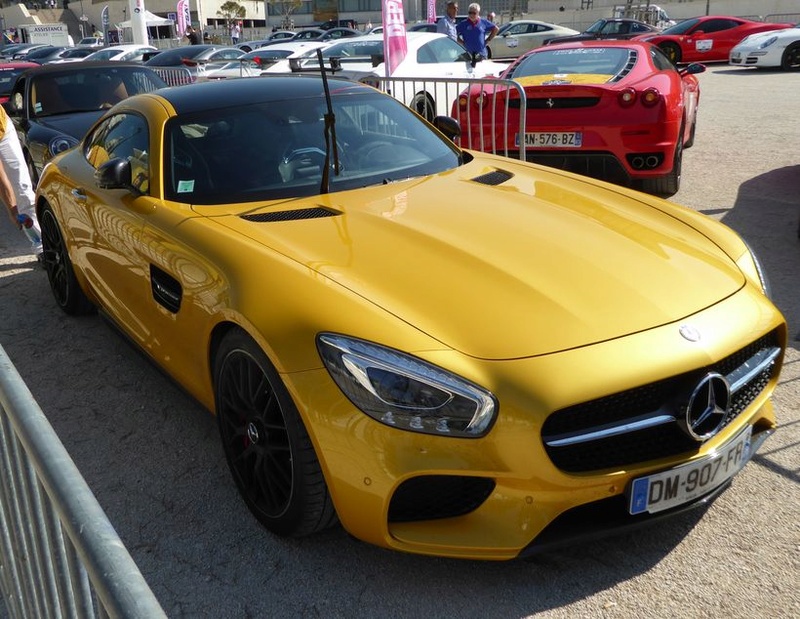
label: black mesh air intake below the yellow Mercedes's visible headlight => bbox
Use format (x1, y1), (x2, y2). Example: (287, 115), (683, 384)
(389, 475), (495, 522)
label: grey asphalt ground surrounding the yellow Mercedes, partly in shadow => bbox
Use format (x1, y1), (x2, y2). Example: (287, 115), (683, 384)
(0, 65), (800, 619)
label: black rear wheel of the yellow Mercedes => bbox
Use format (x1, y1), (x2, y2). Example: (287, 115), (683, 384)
(39, 202), (95, 316)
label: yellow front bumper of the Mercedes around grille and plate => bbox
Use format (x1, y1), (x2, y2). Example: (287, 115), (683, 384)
(285, 286), (786, 560)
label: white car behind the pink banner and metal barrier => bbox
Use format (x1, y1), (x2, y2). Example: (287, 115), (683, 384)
(264, 32), (508, 120)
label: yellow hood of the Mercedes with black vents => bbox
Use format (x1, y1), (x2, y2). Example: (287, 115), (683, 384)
(205, 158), (745, 359)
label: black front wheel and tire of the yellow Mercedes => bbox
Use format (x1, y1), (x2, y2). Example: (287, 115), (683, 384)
(214, 329), (337, 537)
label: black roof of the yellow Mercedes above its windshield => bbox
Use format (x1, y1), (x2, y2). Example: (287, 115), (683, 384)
(152, 75), (372, 114)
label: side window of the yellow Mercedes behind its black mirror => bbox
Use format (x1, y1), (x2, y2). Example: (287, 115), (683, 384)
(84, 113), (150, 193)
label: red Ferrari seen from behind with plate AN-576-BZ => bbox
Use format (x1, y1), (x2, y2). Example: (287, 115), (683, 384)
(453, 41), (705, 196)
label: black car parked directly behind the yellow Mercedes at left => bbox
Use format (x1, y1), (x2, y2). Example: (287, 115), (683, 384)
(3, 62), (166, 184)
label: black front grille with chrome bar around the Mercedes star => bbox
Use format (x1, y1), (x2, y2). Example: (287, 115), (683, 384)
(542, 332), (780, 473)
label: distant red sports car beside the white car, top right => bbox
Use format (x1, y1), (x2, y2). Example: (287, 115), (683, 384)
(634, 15), (792, 64)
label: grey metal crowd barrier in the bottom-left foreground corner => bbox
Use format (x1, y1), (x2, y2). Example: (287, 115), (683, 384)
(0, 346), (166, 619)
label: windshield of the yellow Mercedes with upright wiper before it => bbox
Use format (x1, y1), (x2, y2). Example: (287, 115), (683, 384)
(164, 91), (460, 205)
